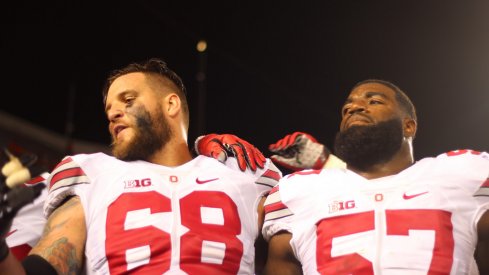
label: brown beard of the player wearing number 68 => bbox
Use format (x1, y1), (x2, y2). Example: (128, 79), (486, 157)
(112, 105), (172, 161)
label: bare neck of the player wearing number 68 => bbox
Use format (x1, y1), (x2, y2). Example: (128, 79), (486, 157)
(148, 140), (193, 167)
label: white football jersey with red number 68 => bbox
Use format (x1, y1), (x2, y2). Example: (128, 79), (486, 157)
(45, 153), (281, 274)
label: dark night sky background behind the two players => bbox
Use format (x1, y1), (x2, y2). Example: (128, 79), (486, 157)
(0, 0), (489, 162)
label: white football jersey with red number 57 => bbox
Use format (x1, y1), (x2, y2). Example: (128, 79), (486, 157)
(263, 150), (489, 275)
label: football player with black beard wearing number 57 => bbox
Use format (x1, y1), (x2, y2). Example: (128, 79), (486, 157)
(263, 80), (489, 274)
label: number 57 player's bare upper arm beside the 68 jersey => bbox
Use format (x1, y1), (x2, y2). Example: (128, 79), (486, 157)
(264, 231), (302, 275)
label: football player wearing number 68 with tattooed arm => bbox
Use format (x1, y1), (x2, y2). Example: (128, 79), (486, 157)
(0, 59), (281, 274)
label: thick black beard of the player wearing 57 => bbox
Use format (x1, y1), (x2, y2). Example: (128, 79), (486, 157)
(334, 118), (403, 171)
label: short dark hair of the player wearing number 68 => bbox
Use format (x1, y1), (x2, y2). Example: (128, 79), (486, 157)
(102, 58), (189, 126)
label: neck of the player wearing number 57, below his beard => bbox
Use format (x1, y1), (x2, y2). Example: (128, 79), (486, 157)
(348, 146), (414, 179)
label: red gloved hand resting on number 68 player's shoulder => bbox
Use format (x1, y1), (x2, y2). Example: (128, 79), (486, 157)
(194, 134), (266, 171)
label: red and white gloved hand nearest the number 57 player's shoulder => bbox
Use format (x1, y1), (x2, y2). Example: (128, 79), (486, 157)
(268, 132), (330, 171)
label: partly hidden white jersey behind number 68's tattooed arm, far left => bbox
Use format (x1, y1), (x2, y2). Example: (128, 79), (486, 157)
(6, 173), (49, 260)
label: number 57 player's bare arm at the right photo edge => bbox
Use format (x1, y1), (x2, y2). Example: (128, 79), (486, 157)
(475, 211), (489, 274)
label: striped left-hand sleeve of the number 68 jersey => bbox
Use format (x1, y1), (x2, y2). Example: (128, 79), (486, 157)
(44, 156), (90, 217)
